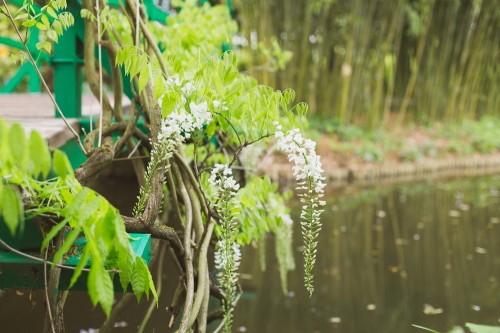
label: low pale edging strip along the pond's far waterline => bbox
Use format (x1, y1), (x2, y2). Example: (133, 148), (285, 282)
(260, 153), (500, 186)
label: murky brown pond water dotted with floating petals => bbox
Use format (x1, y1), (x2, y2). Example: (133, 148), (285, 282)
(0, 176), (500, 333)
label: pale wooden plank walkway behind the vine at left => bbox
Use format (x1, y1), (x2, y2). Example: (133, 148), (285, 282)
(0, 93), (130, 148)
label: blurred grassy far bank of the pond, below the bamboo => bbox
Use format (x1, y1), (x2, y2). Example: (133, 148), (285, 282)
(259, 117), (500, 186)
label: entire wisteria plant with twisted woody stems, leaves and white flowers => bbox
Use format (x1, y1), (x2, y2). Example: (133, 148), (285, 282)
(0, 0), (325, 332)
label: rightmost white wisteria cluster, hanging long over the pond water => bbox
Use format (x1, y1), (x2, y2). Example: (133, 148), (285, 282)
(274, 122), (326, 294)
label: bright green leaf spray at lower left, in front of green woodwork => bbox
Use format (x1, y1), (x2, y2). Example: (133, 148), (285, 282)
(0, 119), (157, 315)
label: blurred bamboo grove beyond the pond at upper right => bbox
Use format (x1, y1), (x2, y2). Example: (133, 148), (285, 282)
(237, 0), (500, 129)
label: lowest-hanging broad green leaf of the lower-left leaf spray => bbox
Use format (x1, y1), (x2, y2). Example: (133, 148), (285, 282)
(87, 262), (114, 317)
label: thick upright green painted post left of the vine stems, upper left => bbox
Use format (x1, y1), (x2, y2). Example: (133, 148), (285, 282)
(52, 0), (83, 118)
